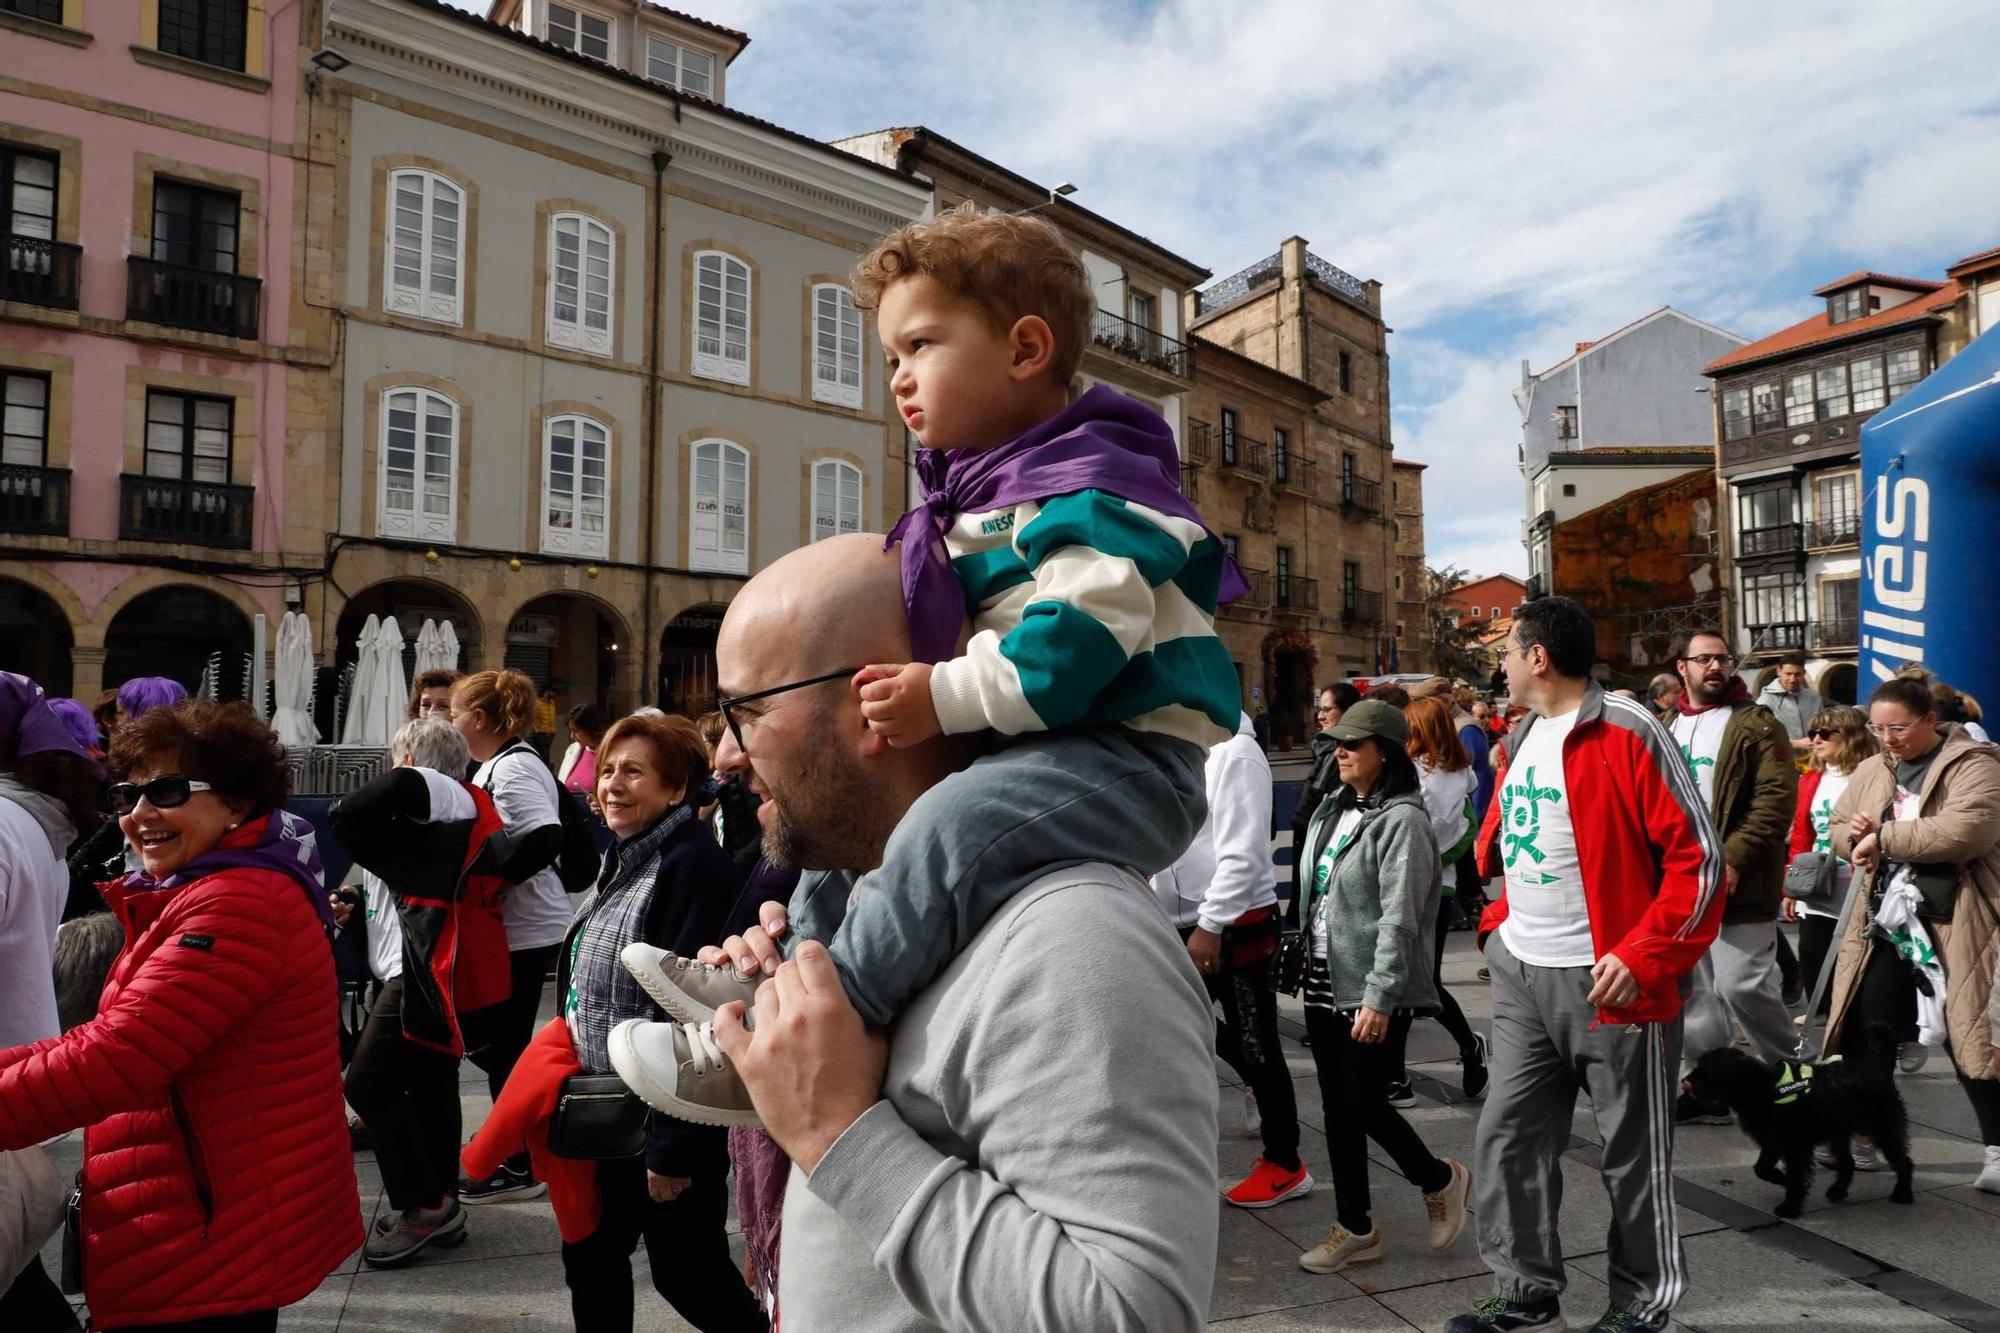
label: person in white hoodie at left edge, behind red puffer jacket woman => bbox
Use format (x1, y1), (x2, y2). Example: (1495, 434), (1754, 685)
(0, 671), (100, 1333)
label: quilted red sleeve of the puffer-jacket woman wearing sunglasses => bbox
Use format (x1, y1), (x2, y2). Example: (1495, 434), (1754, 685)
(0, 873), (294, 1149)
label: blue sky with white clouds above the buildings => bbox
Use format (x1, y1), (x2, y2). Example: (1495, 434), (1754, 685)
(454, 0), (2000, 572)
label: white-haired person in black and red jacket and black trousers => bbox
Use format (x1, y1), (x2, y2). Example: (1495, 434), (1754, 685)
(330, 715), (512, 1267)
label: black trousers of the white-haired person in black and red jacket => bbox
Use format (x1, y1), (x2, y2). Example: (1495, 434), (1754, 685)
(346, 977), (460, 1213)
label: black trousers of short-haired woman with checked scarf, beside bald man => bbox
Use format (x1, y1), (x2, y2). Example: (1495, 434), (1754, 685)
(562, 1159), (770, 1333)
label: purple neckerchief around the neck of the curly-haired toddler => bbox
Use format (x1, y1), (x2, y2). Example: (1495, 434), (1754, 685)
(884, 384), (1250, 662)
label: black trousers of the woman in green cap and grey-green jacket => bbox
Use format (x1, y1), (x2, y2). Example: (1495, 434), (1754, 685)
(1306, 1007), (1452, 1235)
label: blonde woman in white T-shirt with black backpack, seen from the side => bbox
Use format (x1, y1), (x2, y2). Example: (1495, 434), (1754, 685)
(452, 671), (572, 1203)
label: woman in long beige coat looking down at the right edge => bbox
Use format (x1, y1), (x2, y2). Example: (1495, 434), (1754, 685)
(1826, 679), (2000, 1193)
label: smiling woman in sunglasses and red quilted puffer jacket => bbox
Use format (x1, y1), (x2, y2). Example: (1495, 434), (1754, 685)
(0, 703), (362, 1333)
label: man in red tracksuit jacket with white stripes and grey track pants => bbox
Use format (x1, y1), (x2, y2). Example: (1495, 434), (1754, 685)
(1446, 596), (1724, 1333)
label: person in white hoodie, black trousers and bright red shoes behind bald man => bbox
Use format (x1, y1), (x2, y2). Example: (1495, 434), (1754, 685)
(1152, 717), (1312, 1209)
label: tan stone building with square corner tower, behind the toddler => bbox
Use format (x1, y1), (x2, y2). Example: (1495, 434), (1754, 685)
(1186, 236), (1422, 745)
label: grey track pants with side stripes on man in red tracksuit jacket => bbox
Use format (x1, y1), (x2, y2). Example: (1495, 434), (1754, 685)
(1472, 933), (1686, 1319)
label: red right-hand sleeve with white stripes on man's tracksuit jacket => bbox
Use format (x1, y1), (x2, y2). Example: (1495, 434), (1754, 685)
(1610, 729), (1726, 995)
